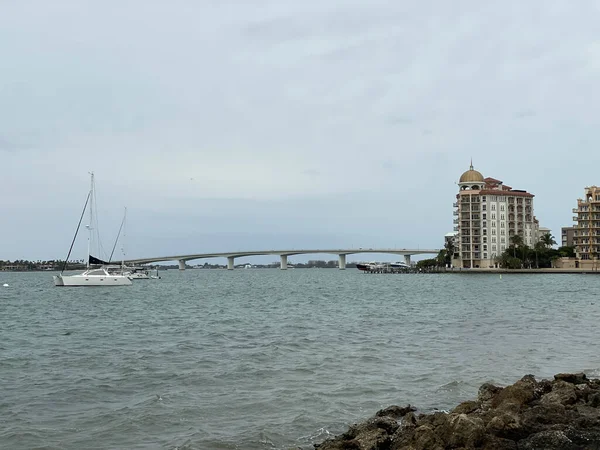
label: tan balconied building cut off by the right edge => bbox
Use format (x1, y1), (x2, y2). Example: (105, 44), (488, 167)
(573, 186), (600, 260)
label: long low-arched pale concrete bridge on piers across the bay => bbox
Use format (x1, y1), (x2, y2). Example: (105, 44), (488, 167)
(125, 248), (439, 270)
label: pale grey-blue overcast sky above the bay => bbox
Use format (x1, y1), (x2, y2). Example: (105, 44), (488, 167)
(0, 0), (600, 261)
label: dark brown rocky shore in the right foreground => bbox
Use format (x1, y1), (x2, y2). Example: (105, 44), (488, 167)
(315, 373), (600, 450)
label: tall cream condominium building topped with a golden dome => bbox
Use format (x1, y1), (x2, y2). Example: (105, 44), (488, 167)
(453, 164), (539, 268)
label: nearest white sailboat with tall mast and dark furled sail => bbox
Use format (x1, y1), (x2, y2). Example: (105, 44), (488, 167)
(53, 172), (132, 286)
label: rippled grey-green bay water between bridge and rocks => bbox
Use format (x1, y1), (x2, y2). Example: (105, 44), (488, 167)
(0, 269), (600, 450)
